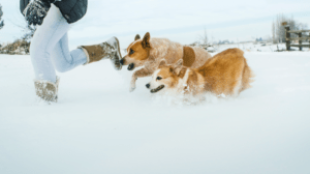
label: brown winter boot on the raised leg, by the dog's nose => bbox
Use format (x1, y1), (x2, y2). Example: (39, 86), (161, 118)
(79, 37), (122, 70)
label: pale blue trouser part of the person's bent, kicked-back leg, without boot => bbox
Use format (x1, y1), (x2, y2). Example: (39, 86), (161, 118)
(52, 34), (87, 72)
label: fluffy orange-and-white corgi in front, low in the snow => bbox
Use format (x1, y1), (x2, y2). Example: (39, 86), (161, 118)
(146, 48), (253, 95)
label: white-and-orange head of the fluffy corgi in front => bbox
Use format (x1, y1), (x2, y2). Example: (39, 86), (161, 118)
(146, 59), (183, 93)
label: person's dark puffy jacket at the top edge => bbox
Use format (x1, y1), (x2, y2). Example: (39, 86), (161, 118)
(20, 0), (88, 24)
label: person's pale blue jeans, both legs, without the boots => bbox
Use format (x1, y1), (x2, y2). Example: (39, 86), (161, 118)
(30, 5), (87, 83)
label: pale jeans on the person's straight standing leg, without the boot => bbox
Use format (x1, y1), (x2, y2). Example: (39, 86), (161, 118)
(30, 5), (70, 83)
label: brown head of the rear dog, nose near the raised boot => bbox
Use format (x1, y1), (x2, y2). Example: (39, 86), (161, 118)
(121, 33), (151, 70)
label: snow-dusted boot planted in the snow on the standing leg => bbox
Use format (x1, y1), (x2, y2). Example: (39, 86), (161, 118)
(34, 78), (59, 102)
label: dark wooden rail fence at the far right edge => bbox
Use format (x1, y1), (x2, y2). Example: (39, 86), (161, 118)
(285, 26), (310, 51)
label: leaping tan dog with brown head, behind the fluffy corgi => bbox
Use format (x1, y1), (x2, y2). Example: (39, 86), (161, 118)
(121, 33), (211, 91)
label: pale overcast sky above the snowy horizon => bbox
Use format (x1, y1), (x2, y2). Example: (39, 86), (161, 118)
(0, 0), (310, 48)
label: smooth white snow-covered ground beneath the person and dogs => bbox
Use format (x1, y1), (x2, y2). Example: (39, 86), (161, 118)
(0, 52), (310, 174)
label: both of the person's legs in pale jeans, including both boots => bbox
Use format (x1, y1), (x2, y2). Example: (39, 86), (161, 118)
(30, 6), (122, 101)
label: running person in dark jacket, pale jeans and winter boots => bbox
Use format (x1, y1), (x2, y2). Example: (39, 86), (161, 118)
(20, 0), (122, 102)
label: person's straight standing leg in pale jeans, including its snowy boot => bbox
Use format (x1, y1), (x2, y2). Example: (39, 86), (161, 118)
(30, 5), (70, 102)
